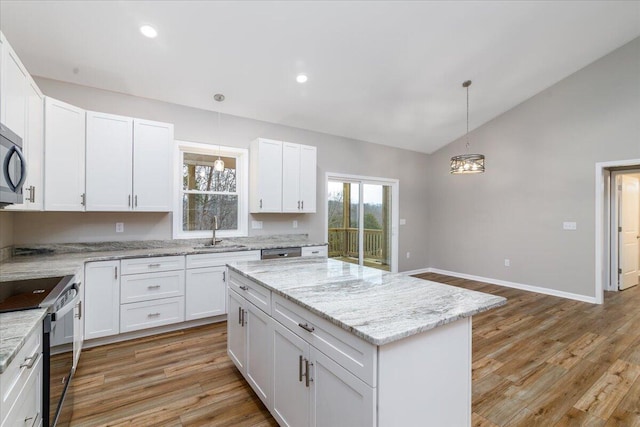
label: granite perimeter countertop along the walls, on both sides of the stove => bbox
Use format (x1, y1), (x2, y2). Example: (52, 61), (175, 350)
(0, 234), (326, 373)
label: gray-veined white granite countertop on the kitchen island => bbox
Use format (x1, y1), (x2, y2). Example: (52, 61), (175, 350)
(229, 257), (507, 345)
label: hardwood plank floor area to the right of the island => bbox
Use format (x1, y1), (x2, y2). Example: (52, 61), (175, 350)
(416, 273), (640, 427)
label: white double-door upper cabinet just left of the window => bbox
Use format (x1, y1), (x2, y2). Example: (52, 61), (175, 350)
(87, 112), (173, 211)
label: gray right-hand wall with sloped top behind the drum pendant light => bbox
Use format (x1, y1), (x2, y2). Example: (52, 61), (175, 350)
(428, 39), (640, 296)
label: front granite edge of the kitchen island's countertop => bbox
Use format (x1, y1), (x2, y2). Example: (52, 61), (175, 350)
(227, 264), (507, 346)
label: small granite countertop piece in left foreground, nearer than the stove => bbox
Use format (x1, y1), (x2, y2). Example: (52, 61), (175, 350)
(0, 308), (47, 374)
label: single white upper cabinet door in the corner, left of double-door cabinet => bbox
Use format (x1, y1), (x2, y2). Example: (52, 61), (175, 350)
(44, 97), (85, 211)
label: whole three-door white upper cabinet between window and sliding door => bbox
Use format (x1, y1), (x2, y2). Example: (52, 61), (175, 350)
(250, 138), (317, 213)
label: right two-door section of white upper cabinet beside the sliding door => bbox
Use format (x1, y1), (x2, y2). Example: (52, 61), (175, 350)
(282, 142), (317, 213)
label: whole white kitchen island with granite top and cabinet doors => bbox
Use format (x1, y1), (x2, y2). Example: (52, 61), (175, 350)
(228, 258), (506, 427)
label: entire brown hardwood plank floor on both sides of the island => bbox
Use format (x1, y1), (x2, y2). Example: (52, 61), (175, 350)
(67, 273), (640, 427)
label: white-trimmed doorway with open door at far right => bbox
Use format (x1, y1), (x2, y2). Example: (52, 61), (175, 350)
(594, 159), (640, 304)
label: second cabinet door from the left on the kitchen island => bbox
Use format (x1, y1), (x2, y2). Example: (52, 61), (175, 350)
(245, 302), (272, 408)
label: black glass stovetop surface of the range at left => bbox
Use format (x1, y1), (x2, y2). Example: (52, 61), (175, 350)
(0, 277), (62, 313)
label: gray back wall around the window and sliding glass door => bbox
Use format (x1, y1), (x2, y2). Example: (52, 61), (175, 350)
(14, 78), (429, 271)
